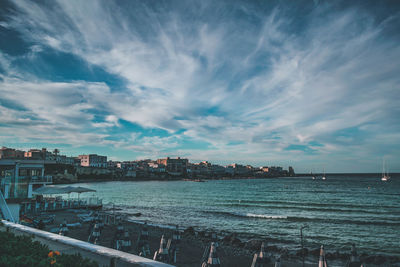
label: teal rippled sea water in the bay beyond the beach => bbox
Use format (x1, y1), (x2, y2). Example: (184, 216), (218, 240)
(72, 175), (400, 256)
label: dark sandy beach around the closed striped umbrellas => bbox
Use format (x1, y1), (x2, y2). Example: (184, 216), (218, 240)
(37, 210), (399, 267)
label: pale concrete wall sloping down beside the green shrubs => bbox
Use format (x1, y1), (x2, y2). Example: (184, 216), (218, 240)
(0, 220), (174, 267)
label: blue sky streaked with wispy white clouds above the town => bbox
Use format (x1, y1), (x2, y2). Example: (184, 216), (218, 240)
(0, 0), (400, 172)
